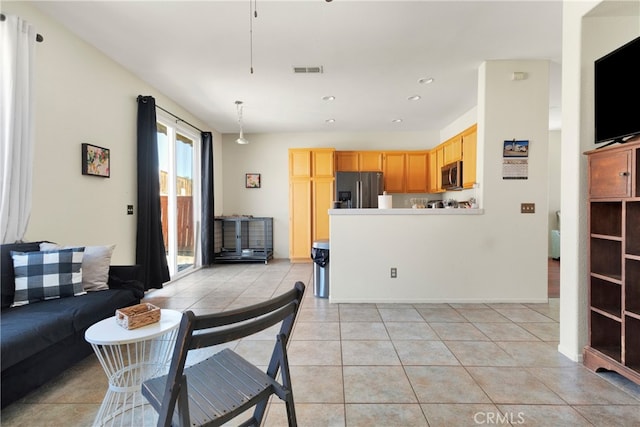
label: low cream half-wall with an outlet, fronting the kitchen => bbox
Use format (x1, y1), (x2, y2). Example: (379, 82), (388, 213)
(329, 208), (548, 304)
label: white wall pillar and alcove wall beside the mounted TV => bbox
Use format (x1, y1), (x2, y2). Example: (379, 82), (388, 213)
(558, 1), (640, 360)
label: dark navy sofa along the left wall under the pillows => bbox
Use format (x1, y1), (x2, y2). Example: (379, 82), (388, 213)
(0, 242), (144, 408)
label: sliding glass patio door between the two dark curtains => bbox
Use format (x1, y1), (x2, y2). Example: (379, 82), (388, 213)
(157, 113), (200, 279)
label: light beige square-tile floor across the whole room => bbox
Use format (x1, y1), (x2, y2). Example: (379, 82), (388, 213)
(1, 260), (640, 427)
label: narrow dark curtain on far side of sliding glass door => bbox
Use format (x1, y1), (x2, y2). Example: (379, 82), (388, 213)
(201, 132), (214, 266)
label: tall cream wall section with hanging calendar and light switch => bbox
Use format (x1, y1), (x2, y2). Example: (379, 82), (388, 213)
(477, 61), (549, 296)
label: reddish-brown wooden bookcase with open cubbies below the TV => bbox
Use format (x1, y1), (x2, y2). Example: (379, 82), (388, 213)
(584, 142), (640, 384)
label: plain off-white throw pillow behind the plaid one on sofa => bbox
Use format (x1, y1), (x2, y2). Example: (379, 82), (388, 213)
(40, 242), (116, 292)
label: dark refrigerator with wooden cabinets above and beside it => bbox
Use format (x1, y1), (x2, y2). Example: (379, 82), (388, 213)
(336, 172), (384, 209)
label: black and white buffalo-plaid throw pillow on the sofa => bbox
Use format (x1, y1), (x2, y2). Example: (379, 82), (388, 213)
(11, 248), (86, 307)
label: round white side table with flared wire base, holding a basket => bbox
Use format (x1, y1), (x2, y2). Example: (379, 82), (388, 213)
(84, 309), (182, 426)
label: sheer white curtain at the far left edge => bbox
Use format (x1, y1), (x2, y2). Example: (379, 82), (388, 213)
(0, 15), (36, 243)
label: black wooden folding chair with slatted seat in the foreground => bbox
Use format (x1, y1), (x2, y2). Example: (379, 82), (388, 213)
(142, 282), (305, 427)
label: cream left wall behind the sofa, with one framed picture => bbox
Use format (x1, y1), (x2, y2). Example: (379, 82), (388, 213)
(2, 2), (222, 264)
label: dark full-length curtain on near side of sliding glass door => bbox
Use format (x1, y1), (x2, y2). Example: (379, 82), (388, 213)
(136, 95), (170, 290)
